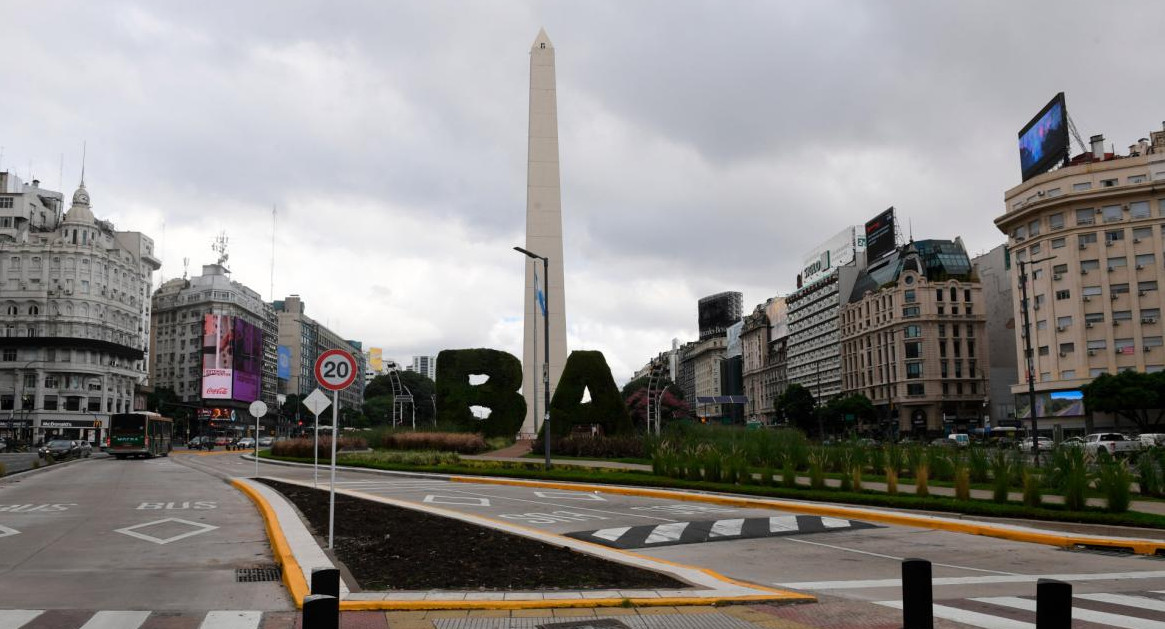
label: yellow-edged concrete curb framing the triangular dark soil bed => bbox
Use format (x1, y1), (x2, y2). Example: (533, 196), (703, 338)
(231, 479), (817, 610)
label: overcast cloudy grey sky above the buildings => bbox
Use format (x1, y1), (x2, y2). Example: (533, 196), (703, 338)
(0, 0), (1165, 383)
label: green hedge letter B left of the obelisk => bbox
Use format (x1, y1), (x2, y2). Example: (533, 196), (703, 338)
(436, 349), (525, 437)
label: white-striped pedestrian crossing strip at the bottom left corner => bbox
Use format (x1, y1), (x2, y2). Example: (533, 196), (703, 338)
(0, 609), (286, 629)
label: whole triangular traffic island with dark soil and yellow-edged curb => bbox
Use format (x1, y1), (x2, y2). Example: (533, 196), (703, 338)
(233, 479), (816, 610)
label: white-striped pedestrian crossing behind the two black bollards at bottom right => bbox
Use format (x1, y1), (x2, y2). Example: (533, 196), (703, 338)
(876, 591), (1165, 629)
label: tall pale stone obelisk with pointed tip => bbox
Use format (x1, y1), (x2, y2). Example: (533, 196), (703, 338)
(522, 29), (566, 433)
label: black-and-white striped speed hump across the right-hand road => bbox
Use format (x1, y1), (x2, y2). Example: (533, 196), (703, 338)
(566, 515), (882, 549)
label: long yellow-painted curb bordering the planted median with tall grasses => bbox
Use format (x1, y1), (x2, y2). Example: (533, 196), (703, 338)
(449, 476), (1165, 554)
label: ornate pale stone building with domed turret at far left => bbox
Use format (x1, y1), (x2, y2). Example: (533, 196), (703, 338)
(0, 172), (161, 443)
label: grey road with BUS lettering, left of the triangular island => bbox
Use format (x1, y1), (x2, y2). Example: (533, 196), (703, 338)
(0, 449), (294, 612)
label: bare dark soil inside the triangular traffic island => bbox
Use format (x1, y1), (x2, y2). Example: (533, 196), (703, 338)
(260, 479), (691, 592)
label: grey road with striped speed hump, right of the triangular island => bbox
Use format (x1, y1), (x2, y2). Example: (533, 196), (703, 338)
(188, 457), (1165, 627)
